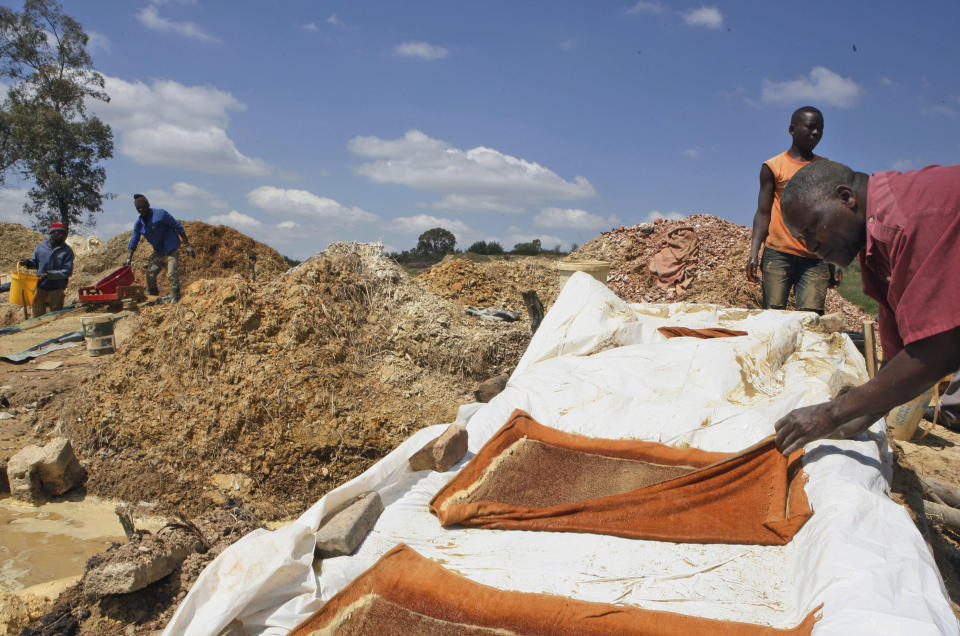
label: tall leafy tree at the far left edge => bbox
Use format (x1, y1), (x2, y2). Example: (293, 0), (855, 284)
(0, 0), (113, 228)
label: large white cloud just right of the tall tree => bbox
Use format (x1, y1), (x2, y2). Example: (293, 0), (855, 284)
(94, 77), (270, 176)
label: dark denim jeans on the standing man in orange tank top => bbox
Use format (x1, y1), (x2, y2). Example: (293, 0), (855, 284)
(760, 247), (830, 315)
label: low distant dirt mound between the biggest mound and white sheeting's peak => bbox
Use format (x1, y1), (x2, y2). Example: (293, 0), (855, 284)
(417, 256), (560, 316)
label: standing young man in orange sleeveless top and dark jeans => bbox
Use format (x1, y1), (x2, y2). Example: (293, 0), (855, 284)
(746, 106), (840, 314)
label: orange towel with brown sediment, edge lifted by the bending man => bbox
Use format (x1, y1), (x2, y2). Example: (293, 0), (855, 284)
(430, 410), (813, 545)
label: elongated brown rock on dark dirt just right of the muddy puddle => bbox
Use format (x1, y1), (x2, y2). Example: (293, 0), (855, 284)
(83, 531), (203, 599)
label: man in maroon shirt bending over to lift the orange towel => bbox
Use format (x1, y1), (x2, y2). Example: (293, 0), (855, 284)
(775, 161), (960, 454)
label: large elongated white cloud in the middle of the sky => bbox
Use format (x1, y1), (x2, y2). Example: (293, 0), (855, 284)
(347, 130), (595, 209)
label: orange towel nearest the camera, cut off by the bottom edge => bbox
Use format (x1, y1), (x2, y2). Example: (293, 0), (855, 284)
(291, 544), (819, 636)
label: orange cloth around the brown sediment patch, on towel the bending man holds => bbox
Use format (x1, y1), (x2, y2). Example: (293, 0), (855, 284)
(430, 410), (813, 545)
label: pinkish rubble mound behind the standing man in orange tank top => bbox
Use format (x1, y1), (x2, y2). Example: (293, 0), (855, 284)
(568, 214), (867, 330)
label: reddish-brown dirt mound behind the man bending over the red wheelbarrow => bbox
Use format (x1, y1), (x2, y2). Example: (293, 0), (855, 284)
(67, 221), (289, 297)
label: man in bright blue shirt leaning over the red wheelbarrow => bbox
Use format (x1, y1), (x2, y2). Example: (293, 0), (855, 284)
(123, 194), (196, 303)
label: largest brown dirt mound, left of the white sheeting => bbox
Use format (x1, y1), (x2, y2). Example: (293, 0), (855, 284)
(63, 244), (529, 519)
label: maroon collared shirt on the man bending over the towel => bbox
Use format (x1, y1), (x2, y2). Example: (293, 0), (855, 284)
(859, 165), (960, 360)
